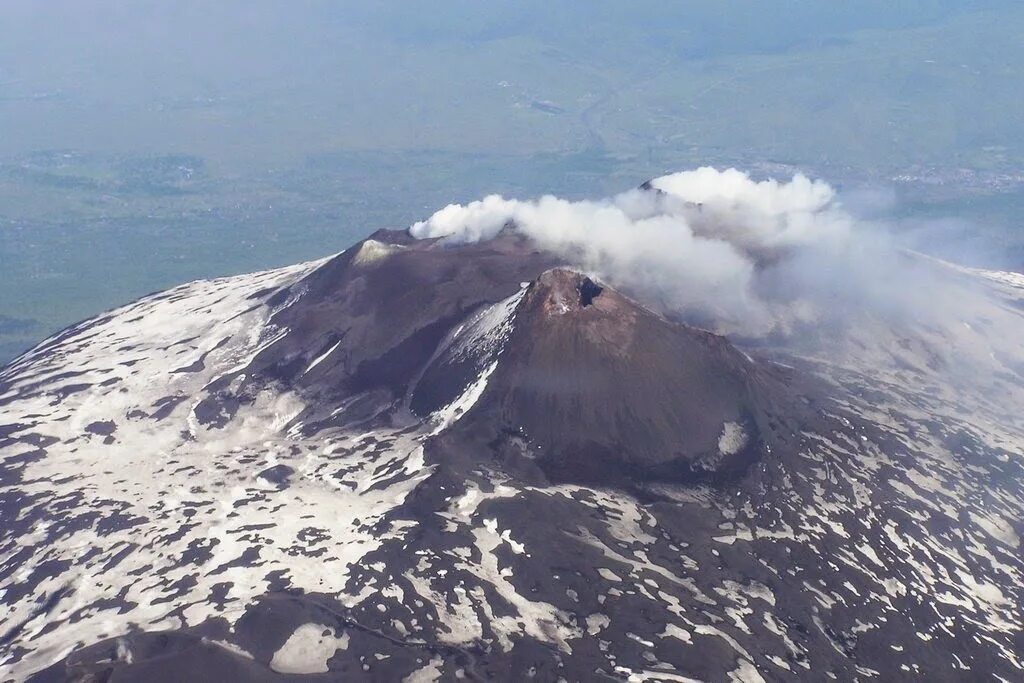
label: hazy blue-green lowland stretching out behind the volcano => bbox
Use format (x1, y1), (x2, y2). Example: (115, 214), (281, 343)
(0, 0), (1024, 358)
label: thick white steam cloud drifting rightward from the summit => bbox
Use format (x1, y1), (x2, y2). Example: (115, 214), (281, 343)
(410, 167), (958, 335)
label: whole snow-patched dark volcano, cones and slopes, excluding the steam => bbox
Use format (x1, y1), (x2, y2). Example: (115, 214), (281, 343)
(0, 231), (1024, 681)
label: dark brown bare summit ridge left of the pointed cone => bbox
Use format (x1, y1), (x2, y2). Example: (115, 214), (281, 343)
(204, 231), (557, 428)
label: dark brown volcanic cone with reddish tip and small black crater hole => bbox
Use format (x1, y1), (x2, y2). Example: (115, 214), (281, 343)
(414, 269), (792, 481)
